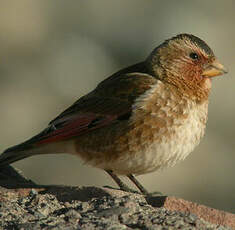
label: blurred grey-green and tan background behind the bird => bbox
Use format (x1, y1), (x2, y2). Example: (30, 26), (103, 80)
(0, 0), (235, 212)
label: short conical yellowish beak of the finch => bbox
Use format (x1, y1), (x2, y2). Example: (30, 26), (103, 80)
(202, 59), (227, 77)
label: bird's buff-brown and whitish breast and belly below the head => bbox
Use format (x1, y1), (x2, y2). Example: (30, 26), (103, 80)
(74, 83), (208, 174)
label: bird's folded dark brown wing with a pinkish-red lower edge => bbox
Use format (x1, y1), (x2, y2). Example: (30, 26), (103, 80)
(33, 73), (157, 144)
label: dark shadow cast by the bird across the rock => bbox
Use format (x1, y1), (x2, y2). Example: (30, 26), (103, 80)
(0, 165), (167, 207)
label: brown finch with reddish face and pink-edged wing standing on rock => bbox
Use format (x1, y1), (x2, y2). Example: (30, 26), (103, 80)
(0, 33), (227, 195)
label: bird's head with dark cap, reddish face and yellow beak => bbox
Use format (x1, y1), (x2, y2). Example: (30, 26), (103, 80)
(147, 34), (226, 102)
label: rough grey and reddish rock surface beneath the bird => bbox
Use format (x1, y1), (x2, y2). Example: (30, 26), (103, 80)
(0, 166), (235, 230)
